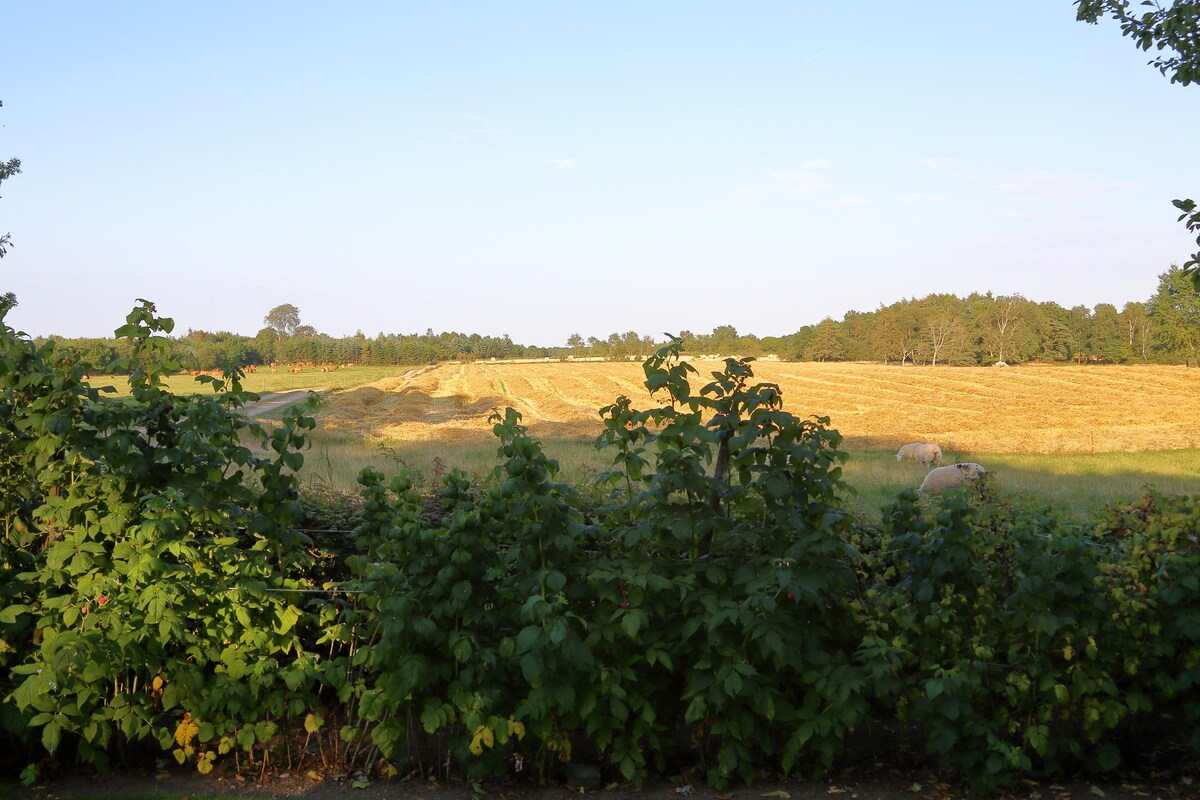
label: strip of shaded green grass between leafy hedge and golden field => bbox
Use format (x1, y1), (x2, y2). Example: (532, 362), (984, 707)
(274, 431), (1200, 522)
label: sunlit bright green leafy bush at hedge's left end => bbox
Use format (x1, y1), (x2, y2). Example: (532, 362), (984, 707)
(0, 301), (313, 771)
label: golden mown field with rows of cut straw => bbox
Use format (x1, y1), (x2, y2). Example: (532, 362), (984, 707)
(318, 361), (1200, 453)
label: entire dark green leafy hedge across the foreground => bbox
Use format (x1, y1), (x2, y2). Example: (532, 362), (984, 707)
(0, 302), (1200, 789)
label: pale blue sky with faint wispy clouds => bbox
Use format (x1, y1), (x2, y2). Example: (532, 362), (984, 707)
(0, 0), (1200, 345)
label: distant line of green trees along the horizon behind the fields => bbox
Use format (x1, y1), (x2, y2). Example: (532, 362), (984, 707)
(37, 265), (1200, 372)
